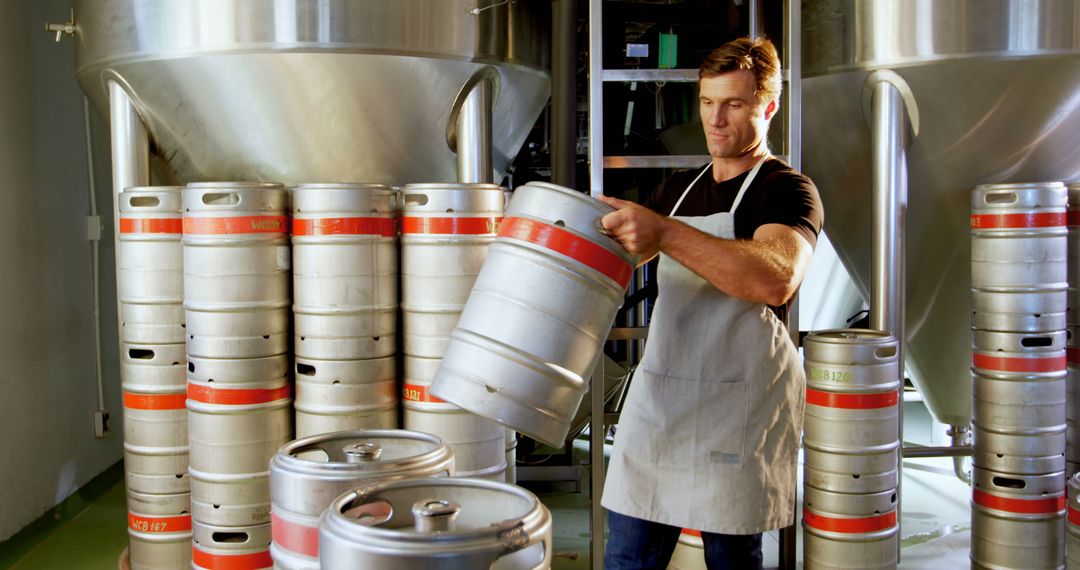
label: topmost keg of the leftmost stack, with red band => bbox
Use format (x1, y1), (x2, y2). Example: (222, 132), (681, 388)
(117, 186), (185, 344)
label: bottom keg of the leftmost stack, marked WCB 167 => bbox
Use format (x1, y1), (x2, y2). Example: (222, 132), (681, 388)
(127, 489), (191, 570)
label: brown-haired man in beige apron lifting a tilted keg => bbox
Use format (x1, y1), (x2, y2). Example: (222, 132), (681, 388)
(602, 39), (823, 570)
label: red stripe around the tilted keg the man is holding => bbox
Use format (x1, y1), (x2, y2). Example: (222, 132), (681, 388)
(499, 218), (634, 288)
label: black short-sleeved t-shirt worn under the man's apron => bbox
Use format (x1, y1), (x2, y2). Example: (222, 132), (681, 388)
(643, 159), (824, 323)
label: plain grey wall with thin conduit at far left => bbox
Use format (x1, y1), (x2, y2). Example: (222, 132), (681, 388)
(0, 0), (122, 540)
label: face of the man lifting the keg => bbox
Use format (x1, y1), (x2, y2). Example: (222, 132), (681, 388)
(699, 69), (777, 159)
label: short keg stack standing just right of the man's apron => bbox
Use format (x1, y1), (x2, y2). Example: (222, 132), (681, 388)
(802, 329), (902, 570)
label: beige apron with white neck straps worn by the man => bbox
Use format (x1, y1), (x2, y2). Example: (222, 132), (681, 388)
(602, 157), (806, 534)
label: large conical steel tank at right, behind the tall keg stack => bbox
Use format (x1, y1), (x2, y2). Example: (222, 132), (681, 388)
(802, 0), (1080, 425)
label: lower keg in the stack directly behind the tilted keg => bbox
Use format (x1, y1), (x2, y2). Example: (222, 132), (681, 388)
(402, 355), (507, 480)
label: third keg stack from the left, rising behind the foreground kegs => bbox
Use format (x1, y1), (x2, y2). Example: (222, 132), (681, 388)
(293, 184), (397, 437)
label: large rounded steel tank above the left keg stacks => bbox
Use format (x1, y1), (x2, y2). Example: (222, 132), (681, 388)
(76, 0), (551, 185)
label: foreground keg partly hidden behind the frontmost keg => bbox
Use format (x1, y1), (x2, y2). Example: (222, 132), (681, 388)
(270, 430), (454, 570)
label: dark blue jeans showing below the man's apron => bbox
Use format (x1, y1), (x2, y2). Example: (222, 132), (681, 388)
(604, 511), (762, 570)
